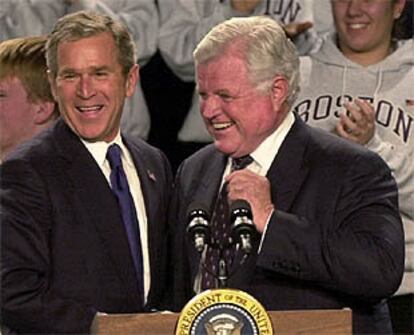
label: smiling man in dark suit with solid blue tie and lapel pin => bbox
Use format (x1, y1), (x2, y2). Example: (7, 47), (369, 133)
(1, 12), (172, 333)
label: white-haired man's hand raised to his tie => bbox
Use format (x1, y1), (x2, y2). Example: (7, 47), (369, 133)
(226, 169), (274, 233)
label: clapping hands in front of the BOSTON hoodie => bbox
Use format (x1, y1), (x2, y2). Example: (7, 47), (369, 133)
(335, 99), (375, 145)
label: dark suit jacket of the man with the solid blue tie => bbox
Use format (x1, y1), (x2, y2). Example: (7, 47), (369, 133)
(1, 120), (172, 333)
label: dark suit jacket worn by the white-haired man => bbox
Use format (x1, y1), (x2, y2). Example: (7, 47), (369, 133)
(170, 120), (404, 333)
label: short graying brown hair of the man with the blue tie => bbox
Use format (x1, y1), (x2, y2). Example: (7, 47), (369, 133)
(46, 11), (137, 77)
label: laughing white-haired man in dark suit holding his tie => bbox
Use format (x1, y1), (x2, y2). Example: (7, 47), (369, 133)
(170, 17), (404, 333)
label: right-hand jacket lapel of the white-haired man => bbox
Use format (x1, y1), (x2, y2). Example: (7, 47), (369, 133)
(267, 119), (309, 211)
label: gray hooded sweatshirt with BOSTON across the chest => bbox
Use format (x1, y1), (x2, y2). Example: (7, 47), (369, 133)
(294, 33), (414, 293)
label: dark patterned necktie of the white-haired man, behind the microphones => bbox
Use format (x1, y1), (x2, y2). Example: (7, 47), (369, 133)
(201, 155), (253, 290)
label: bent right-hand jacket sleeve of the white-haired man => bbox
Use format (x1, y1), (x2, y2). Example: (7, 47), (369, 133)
(258, 154), (404, 300)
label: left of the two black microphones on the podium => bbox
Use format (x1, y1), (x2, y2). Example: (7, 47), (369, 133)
(187, 203), (211, 253)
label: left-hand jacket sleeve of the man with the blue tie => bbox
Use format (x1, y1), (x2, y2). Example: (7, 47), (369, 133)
(0, 160), (96, 333)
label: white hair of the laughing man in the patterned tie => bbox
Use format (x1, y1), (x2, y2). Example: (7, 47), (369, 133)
(193, 16), (300, 105)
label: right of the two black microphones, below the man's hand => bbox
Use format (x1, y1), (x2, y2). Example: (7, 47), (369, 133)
(230, 199), (256, 254)
